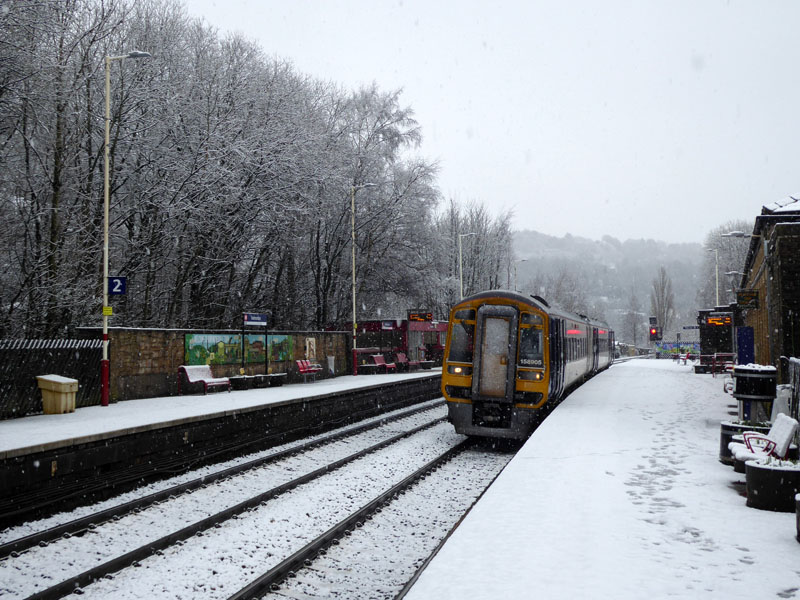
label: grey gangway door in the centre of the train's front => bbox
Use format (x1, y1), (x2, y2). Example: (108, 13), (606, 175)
(472, 305), (519, 400)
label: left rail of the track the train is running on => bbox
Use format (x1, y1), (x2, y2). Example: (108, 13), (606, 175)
(228, 439), (475, 600)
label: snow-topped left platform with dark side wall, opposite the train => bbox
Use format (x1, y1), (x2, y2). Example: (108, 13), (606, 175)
(0, 371), (441, 525)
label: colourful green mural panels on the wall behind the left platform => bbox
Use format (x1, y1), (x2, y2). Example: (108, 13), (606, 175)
(184, 333), (292, 365)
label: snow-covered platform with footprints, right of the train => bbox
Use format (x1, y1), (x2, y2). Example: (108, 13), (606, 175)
(406, 360), (800, 600)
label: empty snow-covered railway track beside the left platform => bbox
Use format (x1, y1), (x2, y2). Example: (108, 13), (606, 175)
(0, 402), (462, 598)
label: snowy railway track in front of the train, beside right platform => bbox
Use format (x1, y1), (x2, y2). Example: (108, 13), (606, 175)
(244, 440), (512, 600)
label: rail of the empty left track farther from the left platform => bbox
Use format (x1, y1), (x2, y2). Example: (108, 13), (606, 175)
(20, 417), (445, 600)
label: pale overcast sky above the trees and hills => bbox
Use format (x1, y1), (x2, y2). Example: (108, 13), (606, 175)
(185, 0), (800, 242)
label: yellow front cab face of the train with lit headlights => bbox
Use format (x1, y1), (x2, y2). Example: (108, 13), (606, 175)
(442, 301), (548, 439)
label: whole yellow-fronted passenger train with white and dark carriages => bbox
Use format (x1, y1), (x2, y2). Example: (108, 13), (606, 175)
(442, 290), (614, 440)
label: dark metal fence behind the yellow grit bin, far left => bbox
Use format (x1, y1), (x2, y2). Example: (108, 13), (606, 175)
(0, 339), (103, 419)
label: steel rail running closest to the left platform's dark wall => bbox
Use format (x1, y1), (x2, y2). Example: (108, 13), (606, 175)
(0, 400), (444, 559)
